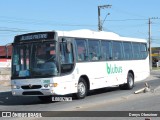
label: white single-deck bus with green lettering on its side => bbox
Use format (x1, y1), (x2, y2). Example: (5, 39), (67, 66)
(11, 30), (150, 100)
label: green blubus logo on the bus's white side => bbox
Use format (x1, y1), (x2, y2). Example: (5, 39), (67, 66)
(106, 63), (122, 74)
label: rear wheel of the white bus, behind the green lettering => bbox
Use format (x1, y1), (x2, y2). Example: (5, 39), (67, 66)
(119, 72), (134, 90)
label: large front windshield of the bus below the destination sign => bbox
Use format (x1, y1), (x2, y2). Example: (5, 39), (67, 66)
(12, 42), (58, 78)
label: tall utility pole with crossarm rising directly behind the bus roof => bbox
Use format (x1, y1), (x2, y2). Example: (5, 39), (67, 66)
(98, 5), (111, 31)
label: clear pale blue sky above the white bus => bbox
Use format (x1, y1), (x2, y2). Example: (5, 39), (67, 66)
(0, 0), (160, 47)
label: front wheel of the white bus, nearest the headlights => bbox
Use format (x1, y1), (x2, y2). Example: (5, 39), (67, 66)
(76, 78), (87, 99)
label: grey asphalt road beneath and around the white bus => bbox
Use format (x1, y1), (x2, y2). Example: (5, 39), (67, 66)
(0, 71), (160, 120)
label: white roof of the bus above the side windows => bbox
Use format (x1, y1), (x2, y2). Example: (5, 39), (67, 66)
(56, 29), (146, 42)
